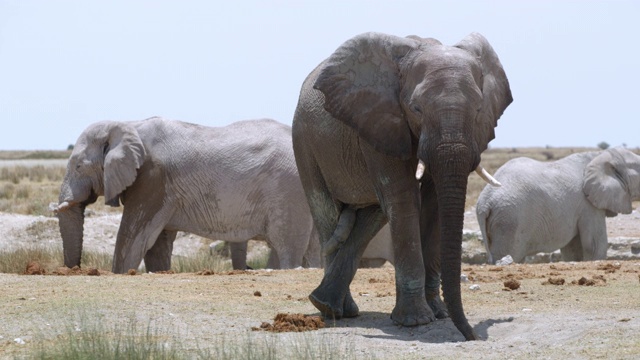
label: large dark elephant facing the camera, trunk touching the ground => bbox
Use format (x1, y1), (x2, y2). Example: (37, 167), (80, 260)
(292, 32), (512, 340)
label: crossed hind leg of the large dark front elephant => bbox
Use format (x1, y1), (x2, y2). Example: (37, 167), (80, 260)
(309, 205), (385, 319)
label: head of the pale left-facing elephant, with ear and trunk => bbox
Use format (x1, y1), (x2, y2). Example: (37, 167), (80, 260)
(54, 121), (145, 267)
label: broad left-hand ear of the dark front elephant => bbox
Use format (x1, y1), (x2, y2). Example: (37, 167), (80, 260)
(313, 33), (419, 159)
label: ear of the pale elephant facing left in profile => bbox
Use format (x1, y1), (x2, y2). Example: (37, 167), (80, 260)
(104, 122), (145, 206)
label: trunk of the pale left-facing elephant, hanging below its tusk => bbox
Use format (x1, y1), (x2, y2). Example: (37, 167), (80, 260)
(57, 204), (85, 268)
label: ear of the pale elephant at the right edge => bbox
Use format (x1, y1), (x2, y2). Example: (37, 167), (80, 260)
(582, 150), (632, 215)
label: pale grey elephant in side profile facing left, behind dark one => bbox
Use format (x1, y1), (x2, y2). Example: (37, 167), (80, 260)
(55, 117), (320, 273)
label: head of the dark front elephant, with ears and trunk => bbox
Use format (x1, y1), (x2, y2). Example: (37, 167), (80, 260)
(314, 33), (512, 339)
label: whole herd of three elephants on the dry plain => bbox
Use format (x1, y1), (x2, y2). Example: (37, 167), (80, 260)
(55, 33), (640, 340)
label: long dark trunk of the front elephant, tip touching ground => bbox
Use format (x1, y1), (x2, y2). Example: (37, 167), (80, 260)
(432, 144), (478, 340)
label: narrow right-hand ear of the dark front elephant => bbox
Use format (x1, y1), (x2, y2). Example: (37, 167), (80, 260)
(455, 32), (513, 152)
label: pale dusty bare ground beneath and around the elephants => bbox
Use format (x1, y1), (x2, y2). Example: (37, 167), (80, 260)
(0, 211), (640, 359)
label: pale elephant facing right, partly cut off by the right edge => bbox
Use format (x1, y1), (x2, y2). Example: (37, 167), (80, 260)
(476, 148), (640, 264)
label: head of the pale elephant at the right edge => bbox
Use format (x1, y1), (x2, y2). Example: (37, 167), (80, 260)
(582, 148), (640, 216)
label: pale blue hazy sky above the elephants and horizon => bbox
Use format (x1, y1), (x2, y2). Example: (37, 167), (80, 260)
(0, 0), (640, 150)
